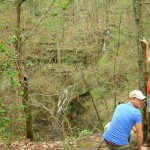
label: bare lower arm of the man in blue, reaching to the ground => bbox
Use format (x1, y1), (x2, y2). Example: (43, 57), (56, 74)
(135, 123), (143, 150)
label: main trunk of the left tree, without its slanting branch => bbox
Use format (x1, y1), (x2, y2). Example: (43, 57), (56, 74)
(15, 0), (33, 140)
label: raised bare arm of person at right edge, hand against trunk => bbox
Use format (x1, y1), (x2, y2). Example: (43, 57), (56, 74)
(140, 37), (150, 64)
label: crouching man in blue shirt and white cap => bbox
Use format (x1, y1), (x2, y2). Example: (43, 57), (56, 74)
(103, 90), (146, 150)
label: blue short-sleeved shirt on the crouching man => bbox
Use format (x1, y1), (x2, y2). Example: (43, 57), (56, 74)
(103, 103), (142, 146)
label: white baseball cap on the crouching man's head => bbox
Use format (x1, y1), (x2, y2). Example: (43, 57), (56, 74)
(129, 90), (146, 100)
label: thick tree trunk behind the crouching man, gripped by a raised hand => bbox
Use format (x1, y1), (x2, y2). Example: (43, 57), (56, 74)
(133, 0), (147, 140)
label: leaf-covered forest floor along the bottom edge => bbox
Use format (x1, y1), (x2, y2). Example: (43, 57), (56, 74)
(0, 133), (150, 150)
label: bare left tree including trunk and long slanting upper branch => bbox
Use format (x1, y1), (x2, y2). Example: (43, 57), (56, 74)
(15, 0), (55, 140)
